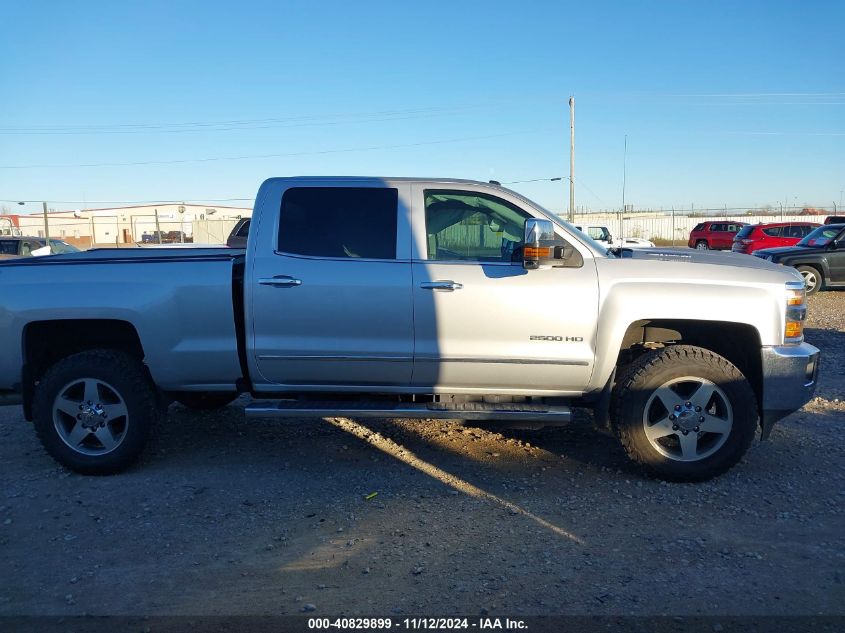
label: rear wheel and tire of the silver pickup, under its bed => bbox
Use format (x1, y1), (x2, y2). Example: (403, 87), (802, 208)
(33, 350), (159, 475)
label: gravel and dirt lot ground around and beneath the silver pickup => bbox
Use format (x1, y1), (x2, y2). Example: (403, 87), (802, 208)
(0, 292), (845, 616)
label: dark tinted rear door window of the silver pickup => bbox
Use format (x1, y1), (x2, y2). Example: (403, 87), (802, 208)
(279, 187), (399, 259)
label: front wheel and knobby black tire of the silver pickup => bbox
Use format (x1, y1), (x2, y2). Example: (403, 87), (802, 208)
(611, 345), (758, 481)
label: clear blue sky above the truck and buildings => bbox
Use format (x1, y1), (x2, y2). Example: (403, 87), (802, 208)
(0, 0), (845, 211)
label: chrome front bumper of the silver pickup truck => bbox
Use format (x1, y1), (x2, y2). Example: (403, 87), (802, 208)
(760, 343), (819, 440)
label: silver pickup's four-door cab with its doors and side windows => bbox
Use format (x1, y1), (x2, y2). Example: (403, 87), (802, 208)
(245, 179), (598, 396)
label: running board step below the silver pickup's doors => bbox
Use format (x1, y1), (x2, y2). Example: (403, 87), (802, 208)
(245, 400), (572, 424)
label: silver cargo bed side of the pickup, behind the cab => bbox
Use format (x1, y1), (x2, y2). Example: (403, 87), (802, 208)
(0, 248), (244, 391)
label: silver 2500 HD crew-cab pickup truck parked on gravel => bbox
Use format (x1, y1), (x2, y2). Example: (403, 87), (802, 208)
(0, 178), (819, 481)
